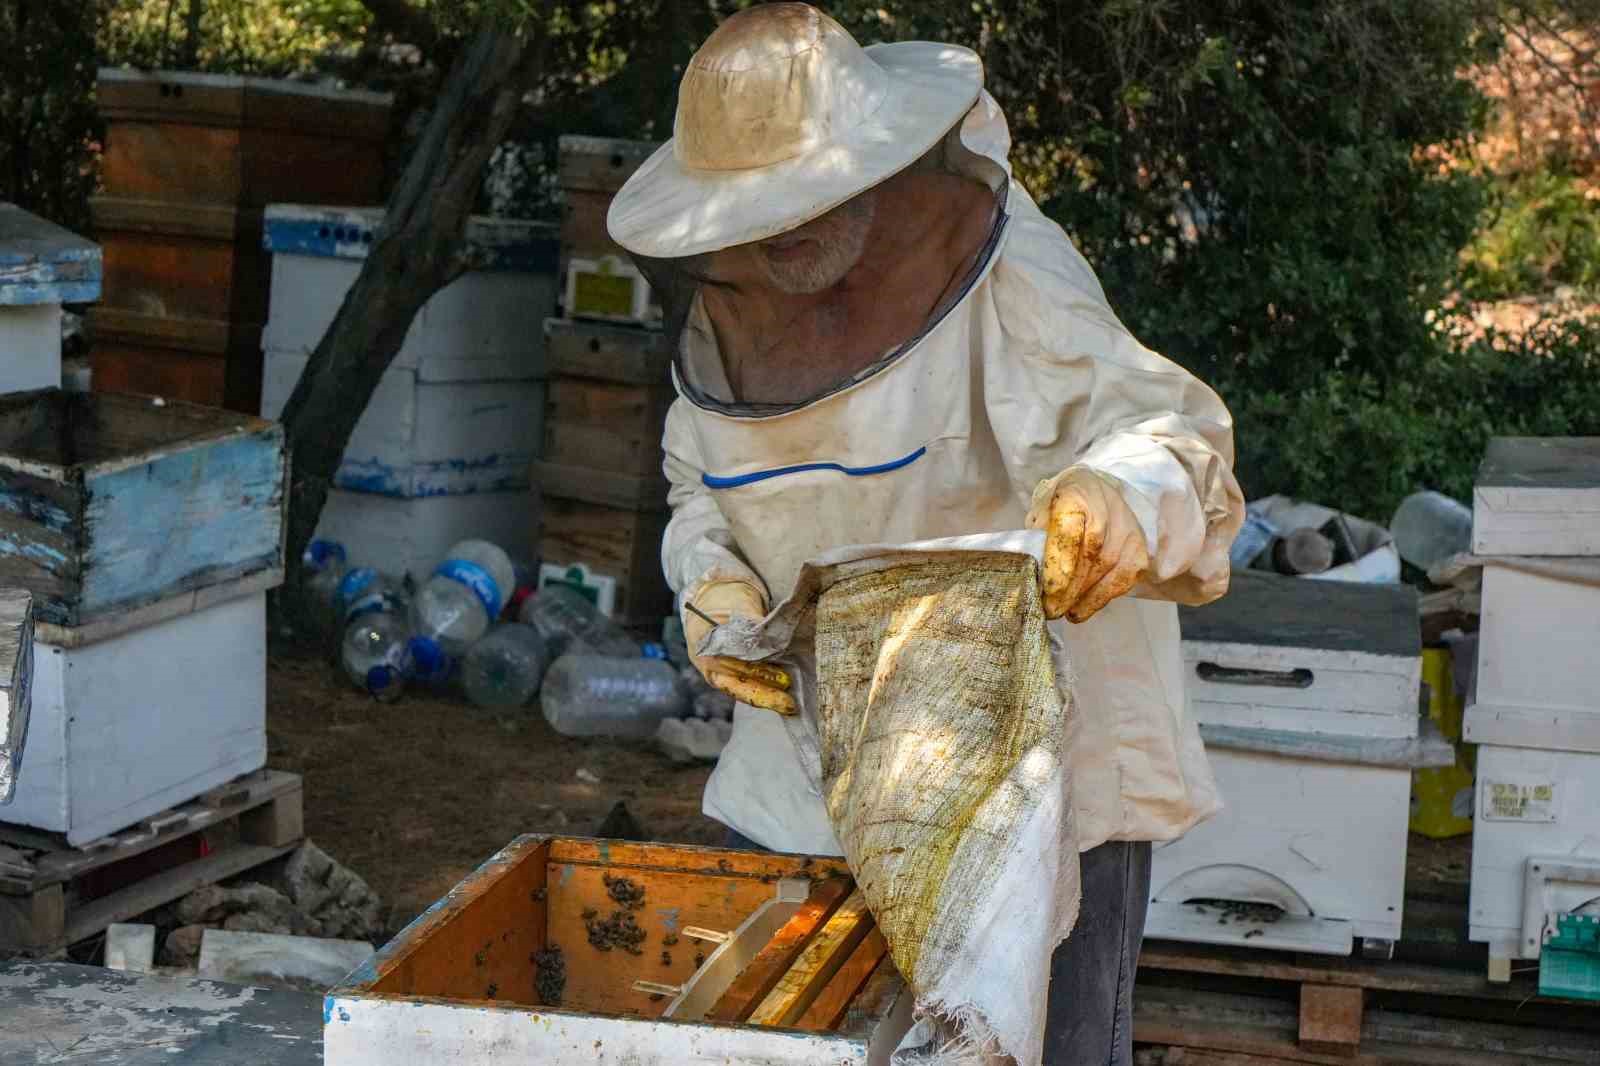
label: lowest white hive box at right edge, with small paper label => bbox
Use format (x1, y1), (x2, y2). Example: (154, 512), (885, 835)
(1469, 744), (1600, 959)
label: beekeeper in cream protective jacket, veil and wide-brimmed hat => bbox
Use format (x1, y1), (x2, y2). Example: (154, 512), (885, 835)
(608, 3), (1243, 1064)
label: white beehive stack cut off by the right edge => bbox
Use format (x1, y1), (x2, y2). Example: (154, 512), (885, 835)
(1464, 437), (1600, 999)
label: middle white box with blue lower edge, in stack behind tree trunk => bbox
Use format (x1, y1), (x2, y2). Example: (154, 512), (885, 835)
(261, 351), (544, 496)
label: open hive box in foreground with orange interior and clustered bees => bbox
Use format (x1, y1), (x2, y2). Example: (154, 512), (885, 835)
(323, 837), (910, 1066)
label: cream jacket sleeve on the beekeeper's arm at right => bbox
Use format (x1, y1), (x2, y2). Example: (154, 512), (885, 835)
(984, 194), (1245, 603)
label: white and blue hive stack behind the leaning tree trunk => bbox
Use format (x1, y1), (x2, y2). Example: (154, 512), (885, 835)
(261, 205), (557, 581)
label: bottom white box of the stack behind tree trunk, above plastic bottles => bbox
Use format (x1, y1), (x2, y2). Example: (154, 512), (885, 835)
(317, 488), (539, 581)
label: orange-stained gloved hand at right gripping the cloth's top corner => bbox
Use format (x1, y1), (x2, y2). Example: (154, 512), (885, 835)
(1027, 466), (1150, 623)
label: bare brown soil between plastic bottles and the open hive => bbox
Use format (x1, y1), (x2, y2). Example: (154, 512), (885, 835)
(267, 647), (723, 930)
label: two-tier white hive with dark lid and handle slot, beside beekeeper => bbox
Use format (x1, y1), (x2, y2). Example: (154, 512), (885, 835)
(1146, 573), (1427, 956)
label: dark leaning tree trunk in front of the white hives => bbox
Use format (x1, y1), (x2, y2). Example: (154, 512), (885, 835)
(283, 19), (544, 624)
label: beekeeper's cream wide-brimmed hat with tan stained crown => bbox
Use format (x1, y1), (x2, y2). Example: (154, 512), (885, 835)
(606, 3), (984, 258)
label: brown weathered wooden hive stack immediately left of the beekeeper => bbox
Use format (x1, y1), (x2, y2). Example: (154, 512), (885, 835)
(534, 138), (674, 624)
